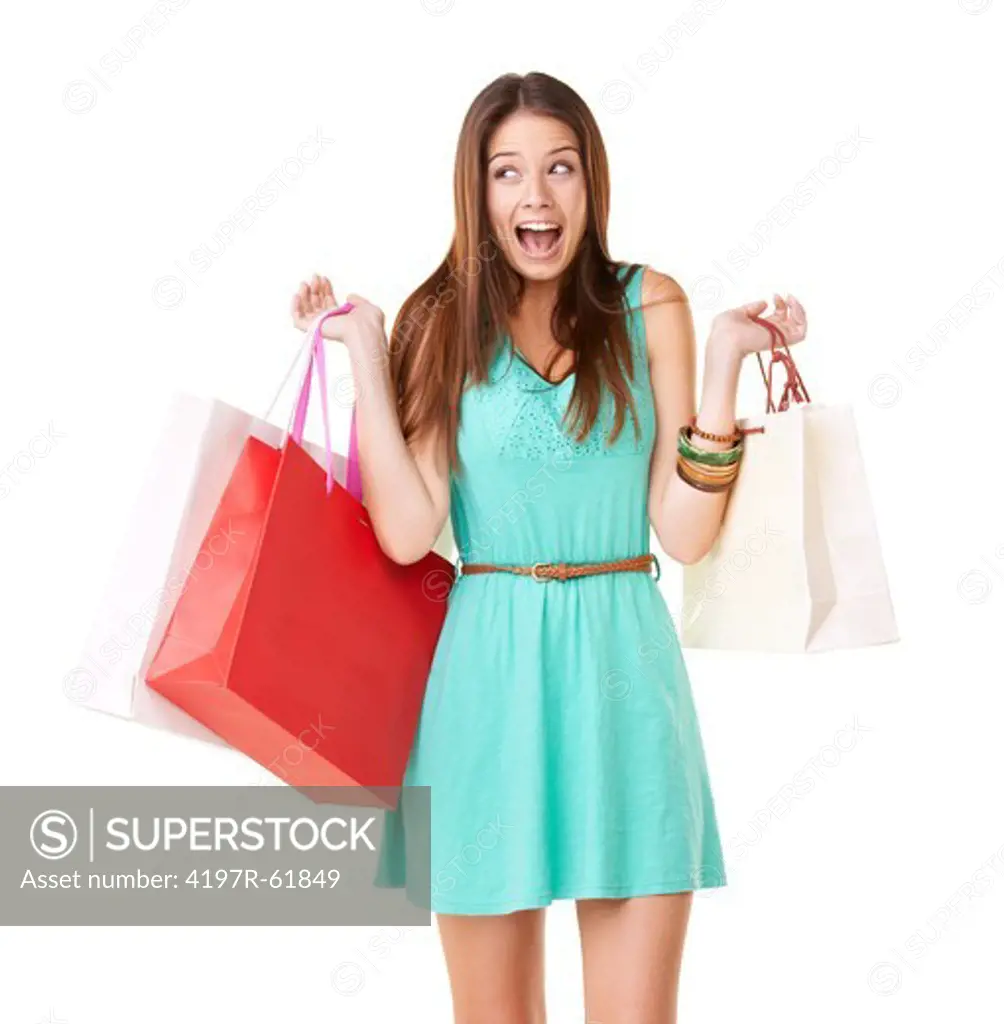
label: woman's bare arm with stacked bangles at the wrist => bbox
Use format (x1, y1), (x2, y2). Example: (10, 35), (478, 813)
(641, 267), (805, 564)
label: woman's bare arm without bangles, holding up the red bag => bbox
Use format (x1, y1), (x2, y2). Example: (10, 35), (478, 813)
(293, 275), (450, 564)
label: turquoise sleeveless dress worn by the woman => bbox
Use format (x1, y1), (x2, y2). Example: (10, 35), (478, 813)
(374, 264), (725, 914)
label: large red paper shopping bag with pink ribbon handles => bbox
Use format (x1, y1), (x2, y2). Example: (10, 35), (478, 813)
(145, 306), (454, 807)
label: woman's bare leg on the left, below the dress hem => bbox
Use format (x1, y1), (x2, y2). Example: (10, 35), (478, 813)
(436, 908), (545, 1024)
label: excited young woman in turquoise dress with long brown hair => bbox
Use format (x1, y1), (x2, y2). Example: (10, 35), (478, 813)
(292, 74), (805, 1024)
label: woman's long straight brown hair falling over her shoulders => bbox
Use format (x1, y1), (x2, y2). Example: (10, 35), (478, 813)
(389, 72), (640, 468)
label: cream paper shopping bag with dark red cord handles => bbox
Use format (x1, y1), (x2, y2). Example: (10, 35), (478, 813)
(680, 321), (898, 652)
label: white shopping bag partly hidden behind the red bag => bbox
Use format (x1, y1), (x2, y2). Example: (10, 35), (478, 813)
(62, 347), (358, 744)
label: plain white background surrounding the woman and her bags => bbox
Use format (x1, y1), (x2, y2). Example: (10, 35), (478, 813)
(0, 0), (1004, 1024)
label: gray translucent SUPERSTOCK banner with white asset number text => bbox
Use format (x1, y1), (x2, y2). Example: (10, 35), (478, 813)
(0, 786), (431, 926)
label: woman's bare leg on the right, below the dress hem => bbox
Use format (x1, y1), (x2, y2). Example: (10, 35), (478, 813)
(576, 892), (694, 1024)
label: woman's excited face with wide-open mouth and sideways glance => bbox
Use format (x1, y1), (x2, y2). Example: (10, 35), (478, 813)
(487, 111), (587, 281)
